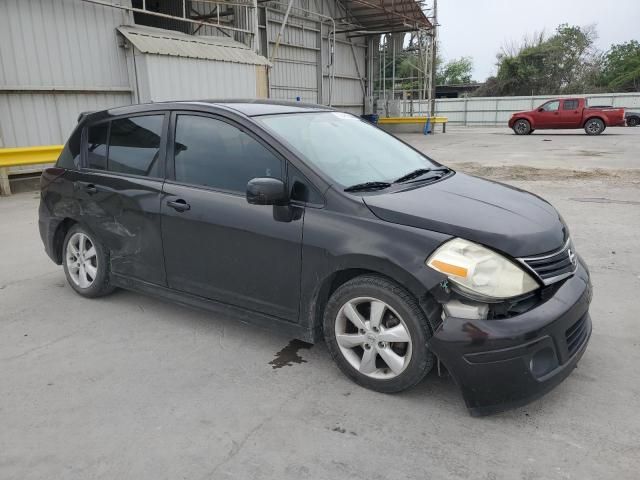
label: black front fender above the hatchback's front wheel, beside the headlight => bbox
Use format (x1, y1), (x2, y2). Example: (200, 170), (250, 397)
(299, 209), (451, 338)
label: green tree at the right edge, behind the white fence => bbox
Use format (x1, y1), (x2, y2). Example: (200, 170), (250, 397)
(600, 40), (640, 92)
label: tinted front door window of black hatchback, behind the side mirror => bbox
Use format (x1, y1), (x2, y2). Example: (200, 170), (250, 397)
(174, 115), (282, 193)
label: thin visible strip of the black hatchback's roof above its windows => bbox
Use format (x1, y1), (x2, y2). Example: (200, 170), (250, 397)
(91, 99), (335, 118)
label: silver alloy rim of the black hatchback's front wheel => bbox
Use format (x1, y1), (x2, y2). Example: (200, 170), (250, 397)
(335, 297), (412, 380)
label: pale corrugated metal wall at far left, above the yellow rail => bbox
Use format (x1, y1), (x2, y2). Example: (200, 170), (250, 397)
(0, 0), (132, 147)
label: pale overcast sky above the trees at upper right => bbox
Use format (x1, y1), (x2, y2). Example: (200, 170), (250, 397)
(438, 0), (640, 81)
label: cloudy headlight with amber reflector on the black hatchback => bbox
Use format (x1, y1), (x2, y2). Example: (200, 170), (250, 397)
(426, 238), (538, 300)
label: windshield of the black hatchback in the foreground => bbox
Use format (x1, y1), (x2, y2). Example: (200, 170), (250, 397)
(256, 112), (438, 186)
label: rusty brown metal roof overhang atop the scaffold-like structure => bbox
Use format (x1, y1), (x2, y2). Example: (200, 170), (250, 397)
(336, 0), (432, 34)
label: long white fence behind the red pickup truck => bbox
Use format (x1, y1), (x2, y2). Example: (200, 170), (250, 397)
(400, 92), (640, 126)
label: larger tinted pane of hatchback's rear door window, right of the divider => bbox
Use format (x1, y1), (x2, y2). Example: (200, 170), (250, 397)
(107, 115), (164, 177)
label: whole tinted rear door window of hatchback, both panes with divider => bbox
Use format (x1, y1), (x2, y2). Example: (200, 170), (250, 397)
(87, 114), (164, 177)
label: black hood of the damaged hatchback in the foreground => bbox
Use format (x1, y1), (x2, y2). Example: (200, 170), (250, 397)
(363, 173), (569, 257)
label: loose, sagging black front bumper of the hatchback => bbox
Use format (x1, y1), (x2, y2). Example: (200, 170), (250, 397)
(429, 260), (592, 416)
